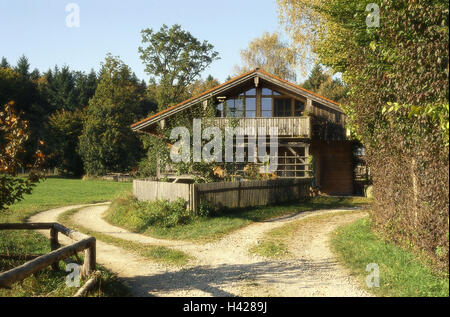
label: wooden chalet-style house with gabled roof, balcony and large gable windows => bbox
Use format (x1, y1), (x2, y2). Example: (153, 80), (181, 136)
(132, 69), (354, 195)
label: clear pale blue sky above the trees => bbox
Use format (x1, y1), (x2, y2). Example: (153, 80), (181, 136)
(0, 0), (288, 82)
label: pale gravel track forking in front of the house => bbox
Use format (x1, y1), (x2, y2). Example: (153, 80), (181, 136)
(30, 204), (369, 297)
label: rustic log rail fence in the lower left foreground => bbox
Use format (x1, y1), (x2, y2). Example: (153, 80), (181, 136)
(0, 223), (97, 291)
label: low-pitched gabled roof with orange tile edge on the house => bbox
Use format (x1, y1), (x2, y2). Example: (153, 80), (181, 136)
(131, 68), (343, 131)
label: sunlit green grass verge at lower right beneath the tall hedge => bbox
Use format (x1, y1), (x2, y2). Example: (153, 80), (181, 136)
(332, 218), (449, 297)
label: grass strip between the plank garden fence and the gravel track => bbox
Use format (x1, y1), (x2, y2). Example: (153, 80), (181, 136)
(106, 197), (370, 242)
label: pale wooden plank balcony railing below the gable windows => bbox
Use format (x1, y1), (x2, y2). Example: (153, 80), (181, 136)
(203, 116), (311, 139)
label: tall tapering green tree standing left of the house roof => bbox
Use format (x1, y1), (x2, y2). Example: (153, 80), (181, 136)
(79, 55), (144, 175)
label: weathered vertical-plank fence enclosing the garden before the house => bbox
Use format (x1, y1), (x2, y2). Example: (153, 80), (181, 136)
(133, 179), (311, 211)
